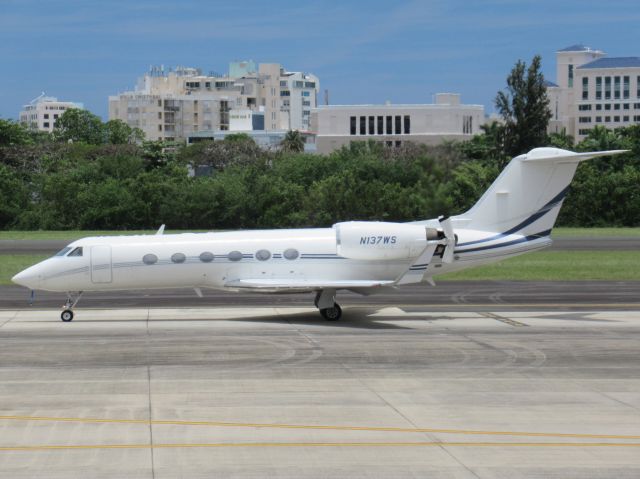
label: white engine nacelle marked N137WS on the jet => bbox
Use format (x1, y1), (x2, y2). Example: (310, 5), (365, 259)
(333, 221), (427, 261)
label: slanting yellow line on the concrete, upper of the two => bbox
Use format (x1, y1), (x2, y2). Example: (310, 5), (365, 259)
(0, 416), (640, 440)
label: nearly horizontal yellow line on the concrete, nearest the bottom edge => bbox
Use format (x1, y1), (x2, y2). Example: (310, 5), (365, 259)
(0, 441), (640, 451)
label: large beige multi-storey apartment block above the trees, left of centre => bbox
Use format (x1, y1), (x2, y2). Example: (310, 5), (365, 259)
(109, 61), (319, 140)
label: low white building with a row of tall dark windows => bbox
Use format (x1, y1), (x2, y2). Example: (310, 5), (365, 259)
(311, 93), (485, 153)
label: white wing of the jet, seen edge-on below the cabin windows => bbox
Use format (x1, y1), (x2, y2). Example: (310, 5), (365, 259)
(225, 278), (393, 291)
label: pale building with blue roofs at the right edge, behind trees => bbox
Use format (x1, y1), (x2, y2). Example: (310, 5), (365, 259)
(547, 45), (640, 142)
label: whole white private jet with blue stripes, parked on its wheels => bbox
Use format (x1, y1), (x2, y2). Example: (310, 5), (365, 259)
(13, 148), (623, 321)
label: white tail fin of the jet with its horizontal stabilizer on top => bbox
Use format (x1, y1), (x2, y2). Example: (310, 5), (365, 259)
(454, 148), (626, 236)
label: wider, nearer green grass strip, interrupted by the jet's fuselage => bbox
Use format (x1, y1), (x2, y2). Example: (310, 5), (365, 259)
(0, 251), (640, 285)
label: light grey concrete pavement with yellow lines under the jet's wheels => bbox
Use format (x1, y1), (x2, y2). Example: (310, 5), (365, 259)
(0, 302), (640, 478)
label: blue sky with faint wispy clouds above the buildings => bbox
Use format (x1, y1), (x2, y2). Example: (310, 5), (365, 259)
(0, 0), (640, 120)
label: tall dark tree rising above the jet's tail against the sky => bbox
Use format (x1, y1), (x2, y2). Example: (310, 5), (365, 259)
(495, 55), (552, 157)
